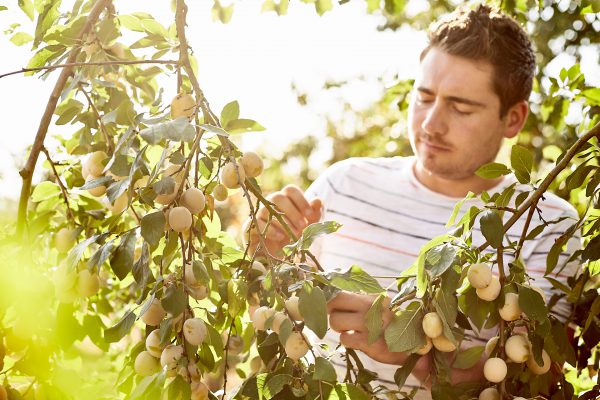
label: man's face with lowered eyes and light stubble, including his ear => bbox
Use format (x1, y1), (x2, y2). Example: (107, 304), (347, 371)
(409, 47), (514, 180)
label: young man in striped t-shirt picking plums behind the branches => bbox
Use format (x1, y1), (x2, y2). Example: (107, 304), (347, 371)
(246, 6), (577, 396)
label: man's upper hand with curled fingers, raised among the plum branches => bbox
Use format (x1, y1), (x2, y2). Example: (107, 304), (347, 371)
(243, 185), (323, 255)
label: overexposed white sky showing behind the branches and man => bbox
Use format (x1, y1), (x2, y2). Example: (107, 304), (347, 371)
(0, 0), (425, 198)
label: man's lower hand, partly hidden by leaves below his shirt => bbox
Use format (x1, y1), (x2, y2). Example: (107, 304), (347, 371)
(327, 292), (407, 365)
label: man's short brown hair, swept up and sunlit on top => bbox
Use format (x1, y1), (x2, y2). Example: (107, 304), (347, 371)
(421, 4), (535, 117)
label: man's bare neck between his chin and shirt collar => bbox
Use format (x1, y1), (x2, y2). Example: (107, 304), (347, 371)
(413, 161), (503, 197)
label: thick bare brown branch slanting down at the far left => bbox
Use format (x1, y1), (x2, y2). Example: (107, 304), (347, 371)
(17, 0), (111, 238)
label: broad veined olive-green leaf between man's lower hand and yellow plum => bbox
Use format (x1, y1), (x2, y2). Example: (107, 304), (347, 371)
(385, 302), (425, 351)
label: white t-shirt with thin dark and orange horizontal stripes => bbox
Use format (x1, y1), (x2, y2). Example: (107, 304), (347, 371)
(306, 157), (579, 399)
